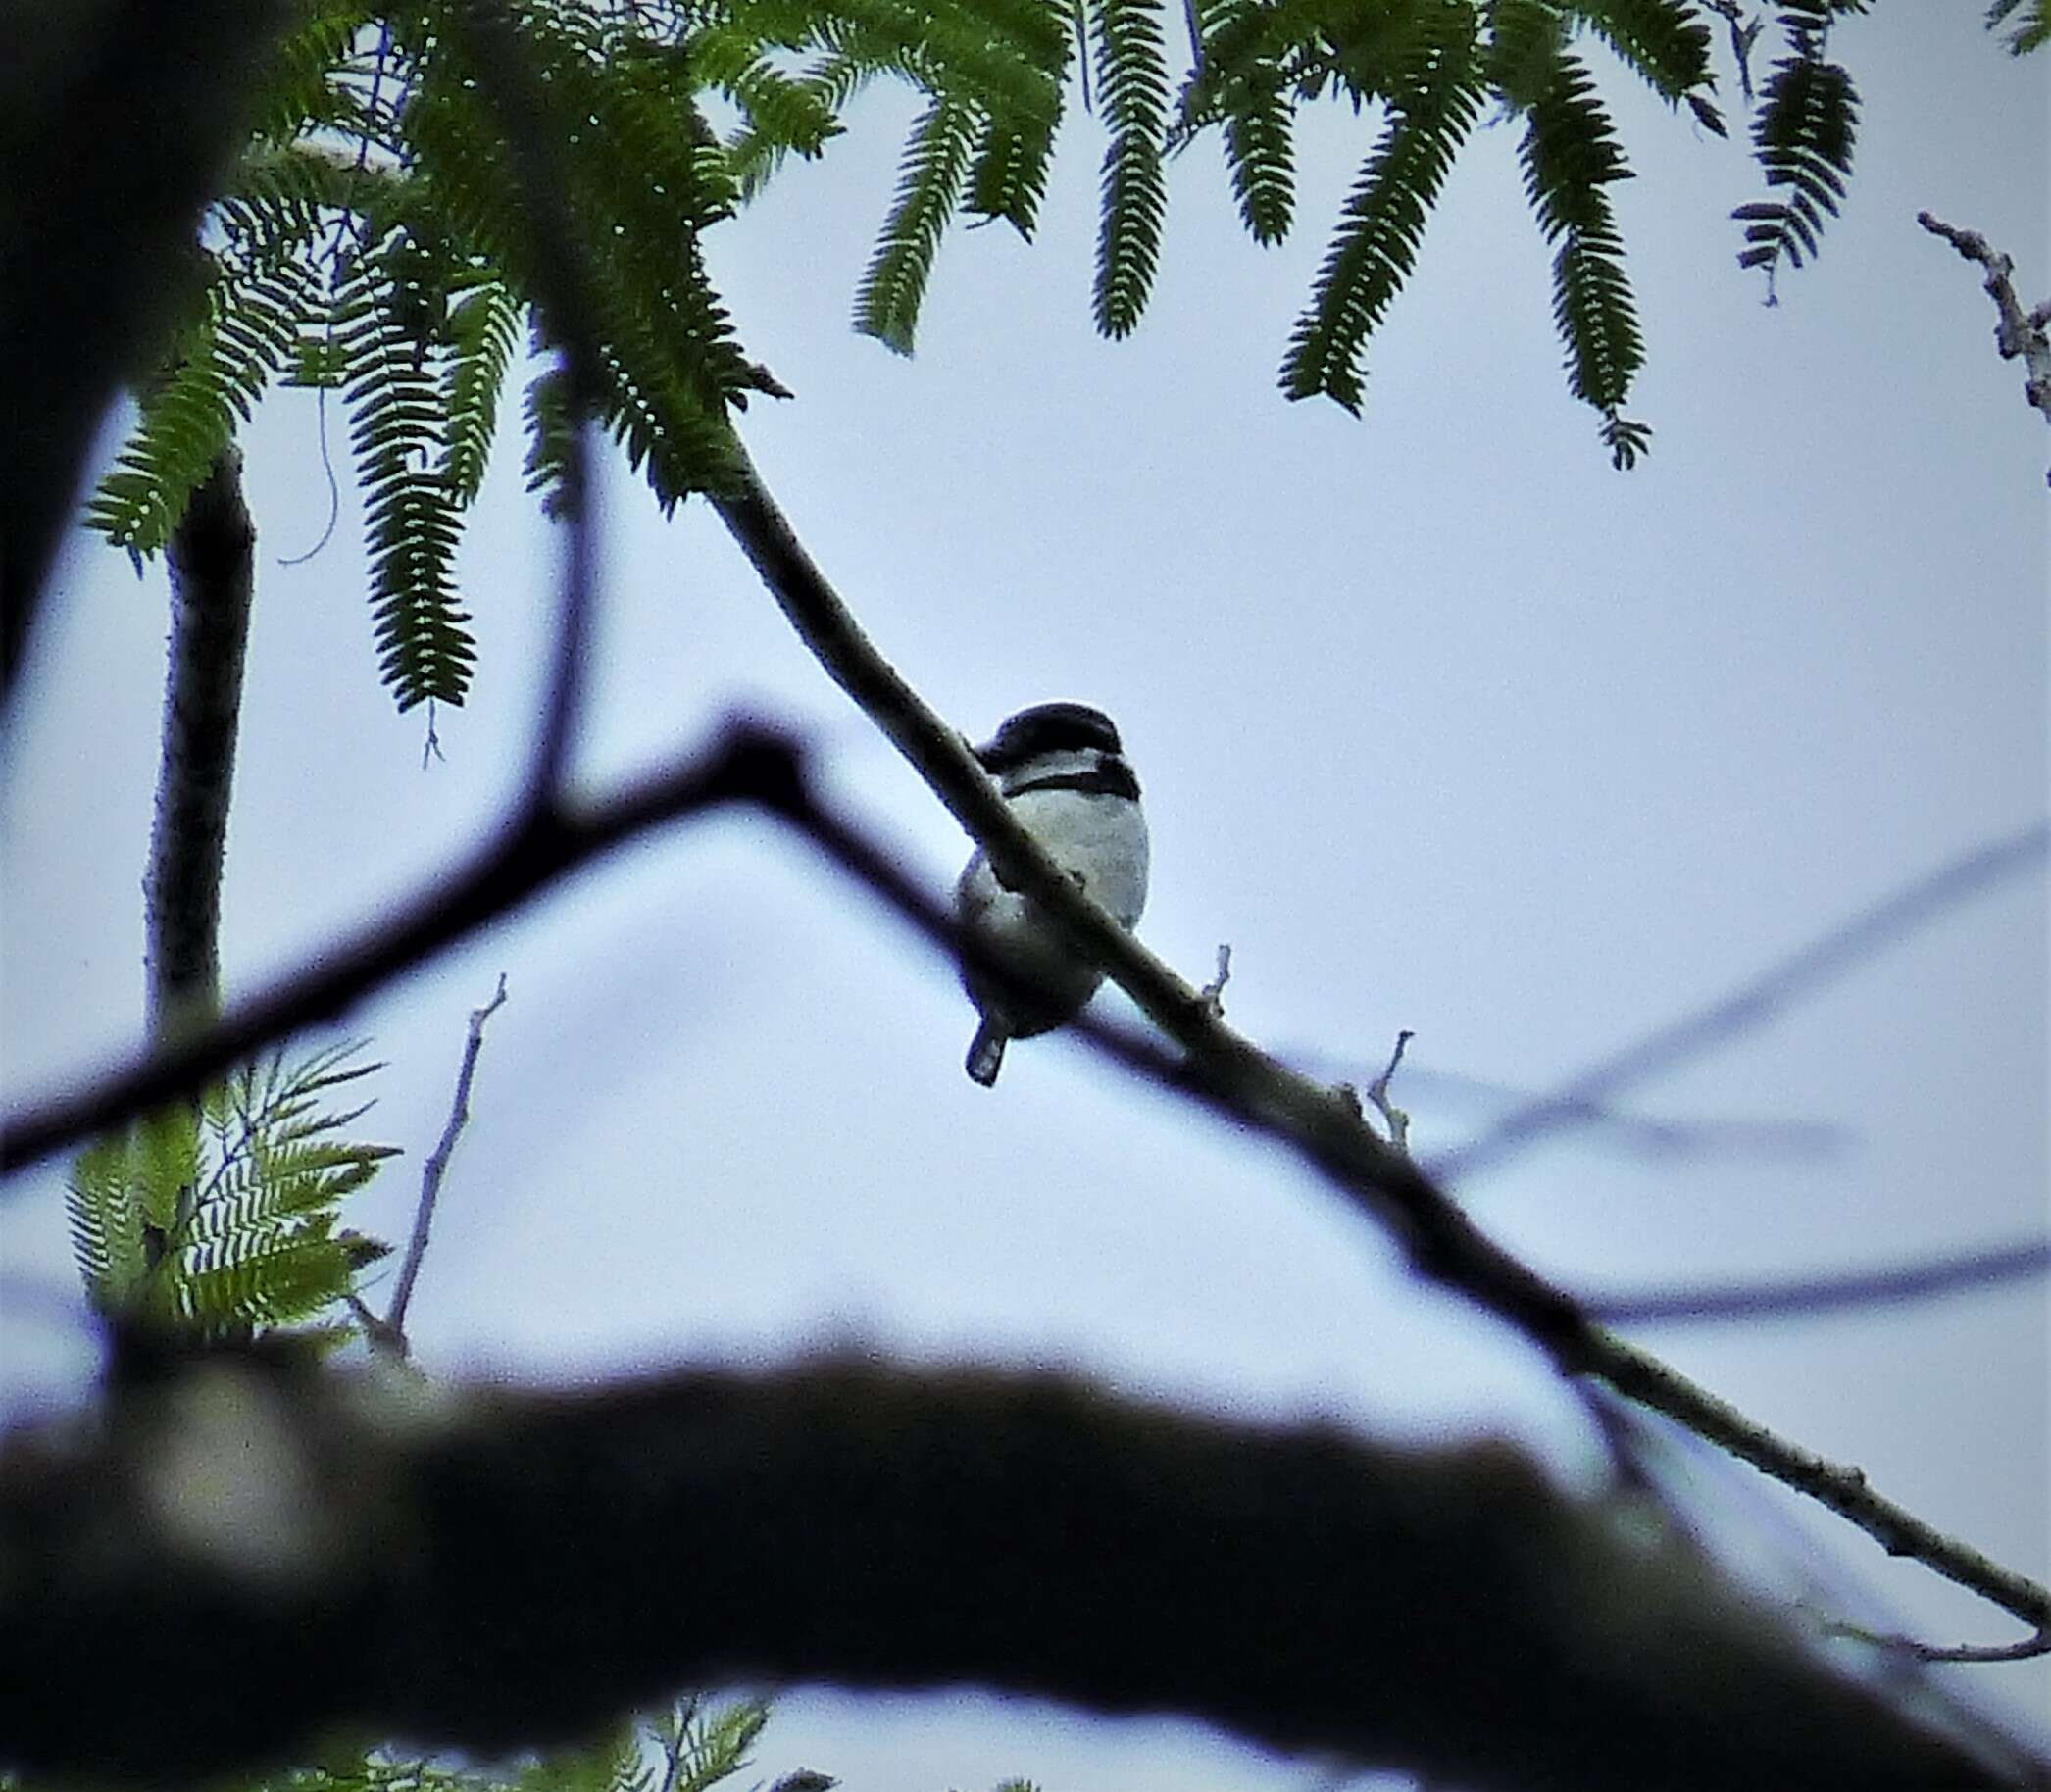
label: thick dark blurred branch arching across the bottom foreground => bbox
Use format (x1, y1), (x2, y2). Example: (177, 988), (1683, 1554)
(0, 1353), (2051, 1792)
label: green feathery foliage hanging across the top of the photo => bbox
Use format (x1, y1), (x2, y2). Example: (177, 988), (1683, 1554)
(72, 0), (1895, 708)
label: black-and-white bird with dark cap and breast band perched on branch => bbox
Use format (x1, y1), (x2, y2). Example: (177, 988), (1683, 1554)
(954, 703), (1146, 1089)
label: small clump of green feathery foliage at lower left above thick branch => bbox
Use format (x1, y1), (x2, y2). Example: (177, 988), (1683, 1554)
(66, 1044), (394, 1339)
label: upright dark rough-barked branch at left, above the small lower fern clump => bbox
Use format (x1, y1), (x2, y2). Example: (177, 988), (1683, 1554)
(143, 445), (257, 1039)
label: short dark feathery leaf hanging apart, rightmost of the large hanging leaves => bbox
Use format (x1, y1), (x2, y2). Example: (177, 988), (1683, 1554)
(1731, 0), (1865, 304)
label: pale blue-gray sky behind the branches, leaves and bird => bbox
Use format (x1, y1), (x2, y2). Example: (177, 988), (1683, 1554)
(0, 6), (2051, 1792)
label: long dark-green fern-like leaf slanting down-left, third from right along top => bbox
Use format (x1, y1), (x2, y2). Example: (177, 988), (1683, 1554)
(1279, 6), (1483, 412)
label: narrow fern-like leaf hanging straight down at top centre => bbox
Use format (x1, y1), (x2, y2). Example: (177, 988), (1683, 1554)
(1091, 0), (1169, 336)
